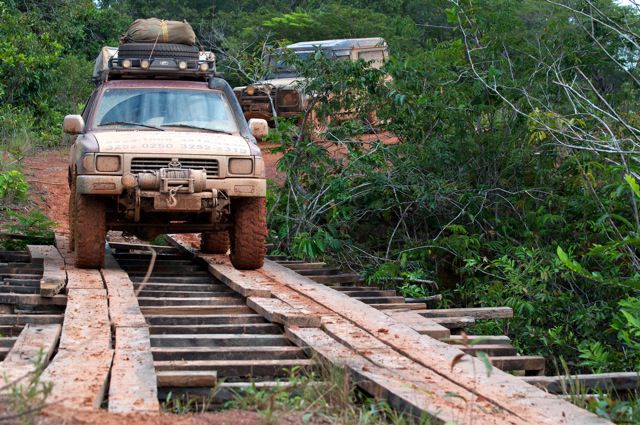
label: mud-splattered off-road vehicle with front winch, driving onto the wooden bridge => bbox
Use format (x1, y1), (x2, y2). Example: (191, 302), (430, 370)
(64, 43), (268, 269)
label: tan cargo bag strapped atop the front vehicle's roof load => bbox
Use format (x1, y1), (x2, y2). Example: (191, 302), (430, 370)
(120, 18), (196, 46)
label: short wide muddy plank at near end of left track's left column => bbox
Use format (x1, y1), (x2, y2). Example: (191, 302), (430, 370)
(42, 350), (113, 410)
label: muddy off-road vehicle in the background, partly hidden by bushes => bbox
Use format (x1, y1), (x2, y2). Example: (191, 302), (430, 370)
(233, 37), (389, 123)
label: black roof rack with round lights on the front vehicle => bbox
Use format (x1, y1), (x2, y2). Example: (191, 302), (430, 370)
(93, 47), (216, 84)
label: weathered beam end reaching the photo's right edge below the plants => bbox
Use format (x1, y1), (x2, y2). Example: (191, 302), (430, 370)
(521, 372), (640, 394)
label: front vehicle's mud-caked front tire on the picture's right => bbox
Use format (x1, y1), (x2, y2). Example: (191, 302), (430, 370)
(230, 198), (267, 270)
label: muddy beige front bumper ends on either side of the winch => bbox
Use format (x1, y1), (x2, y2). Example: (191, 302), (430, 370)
(76, 175), (267, 198)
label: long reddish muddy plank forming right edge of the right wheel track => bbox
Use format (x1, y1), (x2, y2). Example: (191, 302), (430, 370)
(261, 260), (607, 424)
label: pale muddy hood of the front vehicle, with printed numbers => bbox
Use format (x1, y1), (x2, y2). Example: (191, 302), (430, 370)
(93, 131), (251, 155)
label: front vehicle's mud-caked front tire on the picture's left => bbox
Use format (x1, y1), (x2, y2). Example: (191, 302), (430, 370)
(75, 193), (107, 269)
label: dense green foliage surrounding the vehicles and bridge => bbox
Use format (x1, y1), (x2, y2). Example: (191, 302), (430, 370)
(0, 0), (640, 382)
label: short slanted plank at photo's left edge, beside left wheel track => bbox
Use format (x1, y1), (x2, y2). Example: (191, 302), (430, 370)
(0, 325), (62, 382)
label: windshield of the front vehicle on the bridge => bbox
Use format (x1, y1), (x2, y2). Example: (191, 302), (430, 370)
(94, 88), (238, 133)
